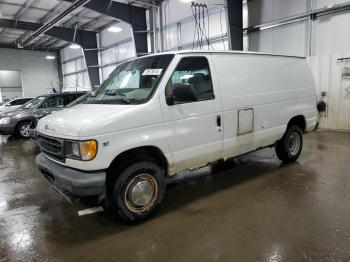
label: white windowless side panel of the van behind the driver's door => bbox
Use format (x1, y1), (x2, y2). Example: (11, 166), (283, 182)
(212, 54), (317, 158)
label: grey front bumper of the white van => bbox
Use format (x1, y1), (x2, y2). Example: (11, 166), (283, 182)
(36, 153), (106, 197)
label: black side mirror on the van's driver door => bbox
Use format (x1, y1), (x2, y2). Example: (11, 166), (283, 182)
(166, 84), (197, 105)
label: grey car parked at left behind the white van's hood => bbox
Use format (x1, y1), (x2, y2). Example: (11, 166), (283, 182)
(0, 92), (85, 138)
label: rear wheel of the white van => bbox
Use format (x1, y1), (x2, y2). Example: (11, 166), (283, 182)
(275, 126), (303, 162)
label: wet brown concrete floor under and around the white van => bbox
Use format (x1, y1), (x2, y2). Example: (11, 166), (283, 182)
(0, 132), (350, 262)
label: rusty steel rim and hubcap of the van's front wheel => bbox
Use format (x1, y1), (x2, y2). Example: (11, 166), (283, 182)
(124, 173), (158, 213)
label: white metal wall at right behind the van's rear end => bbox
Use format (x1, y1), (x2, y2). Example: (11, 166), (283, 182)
(246, 0), (350, 130)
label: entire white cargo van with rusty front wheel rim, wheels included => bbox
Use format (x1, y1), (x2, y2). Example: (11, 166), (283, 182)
(37, 51), (317, 221)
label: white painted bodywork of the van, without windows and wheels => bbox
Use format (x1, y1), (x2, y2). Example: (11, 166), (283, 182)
(37, 51), (318, 219)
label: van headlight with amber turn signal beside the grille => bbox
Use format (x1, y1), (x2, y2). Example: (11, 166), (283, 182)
(65, 140), (97, 161)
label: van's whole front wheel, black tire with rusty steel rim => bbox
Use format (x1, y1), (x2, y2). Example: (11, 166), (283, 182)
(107, 161), (166, 223)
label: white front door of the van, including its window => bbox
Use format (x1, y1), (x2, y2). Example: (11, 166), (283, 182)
(162, 56), (223, 171)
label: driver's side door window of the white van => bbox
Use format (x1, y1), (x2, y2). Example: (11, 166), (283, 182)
(166, 57), (215, 103)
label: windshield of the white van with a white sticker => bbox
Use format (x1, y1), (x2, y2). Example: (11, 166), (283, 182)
(85, 55), (174, 104)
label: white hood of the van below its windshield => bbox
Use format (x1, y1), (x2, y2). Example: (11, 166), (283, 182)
(37, 104), (154, 139)
